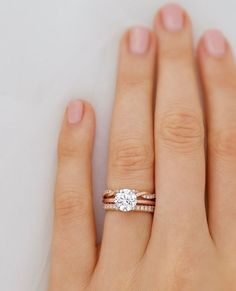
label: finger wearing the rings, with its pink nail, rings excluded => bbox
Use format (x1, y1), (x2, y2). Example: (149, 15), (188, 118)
(101, 27), (155, 268)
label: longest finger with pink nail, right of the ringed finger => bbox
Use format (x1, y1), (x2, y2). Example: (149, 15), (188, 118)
(150, 4), (206, 245)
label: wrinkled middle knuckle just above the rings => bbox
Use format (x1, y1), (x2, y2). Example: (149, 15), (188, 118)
(111, 139), (154, 172)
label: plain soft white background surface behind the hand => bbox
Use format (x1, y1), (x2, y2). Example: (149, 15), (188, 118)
(0, 0), (236, 291)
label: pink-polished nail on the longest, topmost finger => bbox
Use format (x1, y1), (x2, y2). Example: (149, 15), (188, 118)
(161, 4), (184, 32)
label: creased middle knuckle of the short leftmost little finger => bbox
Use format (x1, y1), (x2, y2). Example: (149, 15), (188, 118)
(55, 190), (88, 223)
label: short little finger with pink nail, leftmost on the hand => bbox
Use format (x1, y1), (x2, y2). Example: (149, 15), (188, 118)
(50, 101), (96, 291)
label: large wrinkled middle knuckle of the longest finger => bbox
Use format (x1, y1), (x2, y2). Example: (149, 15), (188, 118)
(157, 110), (204, 152)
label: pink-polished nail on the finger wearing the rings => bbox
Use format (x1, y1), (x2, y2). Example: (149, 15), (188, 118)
(129, 27), (150, 55)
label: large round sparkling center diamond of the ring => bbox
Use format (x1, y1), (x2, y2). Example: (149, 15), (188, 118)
(115, 189), (137, 211)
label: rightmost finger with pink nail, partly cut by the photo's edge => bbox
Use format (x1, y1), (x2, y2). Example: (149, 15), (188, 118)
(198, 30), (236, 258)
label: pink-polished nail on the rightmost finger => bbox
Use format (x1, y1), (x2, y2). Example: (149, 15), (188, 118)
(204, 30), (226, 57)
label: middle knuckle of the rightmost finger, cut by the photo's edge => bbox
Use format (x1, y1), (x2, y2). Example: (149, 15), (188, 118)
(209, 128), (236, 157)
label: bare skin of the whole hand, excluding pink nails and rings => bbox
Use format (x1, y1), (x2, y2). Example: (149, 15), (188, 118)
(48, 4), (236, 291)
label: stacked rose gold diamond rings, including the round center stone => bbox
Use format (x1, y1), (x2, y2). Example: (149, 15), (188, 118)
(103, 189), (156, 212)
